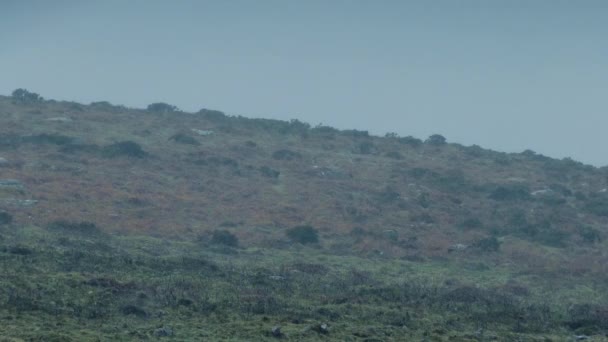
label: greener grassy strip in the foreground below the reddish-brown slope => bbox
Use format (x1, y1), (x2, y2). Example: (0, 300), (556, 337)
(0, 226), (608, 341)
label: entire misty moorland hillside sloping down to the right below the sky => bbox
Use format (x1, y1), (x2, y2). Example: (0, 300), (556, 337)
(0, 92), (608, 341)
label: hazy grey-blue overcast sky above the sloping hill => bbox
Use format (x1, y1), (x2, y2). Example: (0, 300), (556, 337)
(0, 0), (608, 166)
